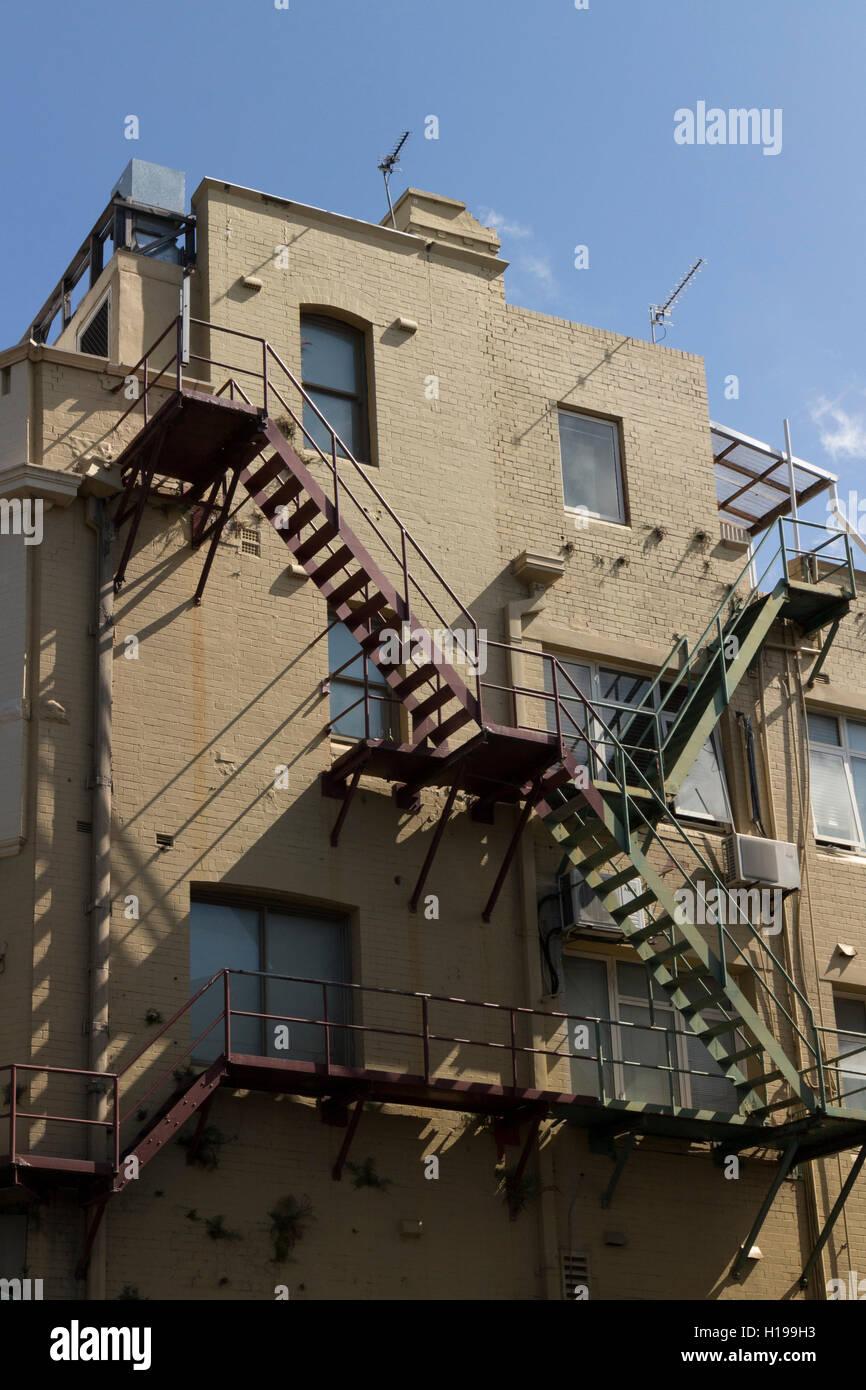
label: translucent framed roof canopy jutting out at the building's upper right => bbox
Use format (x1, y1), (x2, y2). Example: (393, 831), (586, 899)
(710, 421), (838, 535)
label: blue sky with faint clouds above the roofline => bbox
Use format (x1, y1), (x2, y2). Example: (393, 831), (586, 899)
(0, 0), (866, 517)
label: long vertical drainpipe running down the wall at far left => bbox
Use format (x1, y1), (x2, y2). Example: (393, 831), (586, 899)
(86, 498), (114, 1300)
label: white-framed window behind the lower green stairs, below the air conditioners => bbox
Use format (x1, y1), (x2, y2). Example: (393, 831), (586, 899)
(563, 955), (737, 1113)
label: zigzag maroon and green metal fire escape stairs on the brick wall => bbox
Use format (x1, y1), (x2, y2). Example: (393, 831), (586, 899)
(6, 312), (862, 1273)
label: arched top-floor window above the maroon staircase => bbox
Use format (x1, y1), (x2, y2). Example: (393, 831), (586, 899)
(300, 314), (370, 463)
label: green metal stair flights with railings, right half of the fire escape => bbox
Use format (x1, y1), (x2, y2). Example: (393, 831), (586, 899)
(534, 521), (855, 1123)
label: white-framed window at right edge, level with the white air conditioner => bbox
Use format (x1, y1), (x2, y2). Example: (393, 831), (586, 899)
(808, 710), (866, 848)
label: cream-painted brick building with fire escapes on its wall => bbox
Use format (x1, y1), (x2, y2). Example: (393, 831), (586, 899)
(0, 164), (866, 1300)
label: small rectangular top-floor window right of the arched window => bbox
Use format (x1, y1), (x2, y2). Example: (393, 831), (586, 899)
(559, 410), (626, 524)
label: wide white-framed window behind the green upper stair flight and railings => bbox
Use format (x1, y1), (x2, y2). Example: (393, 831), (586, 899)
(545, 657), (733, 826)
